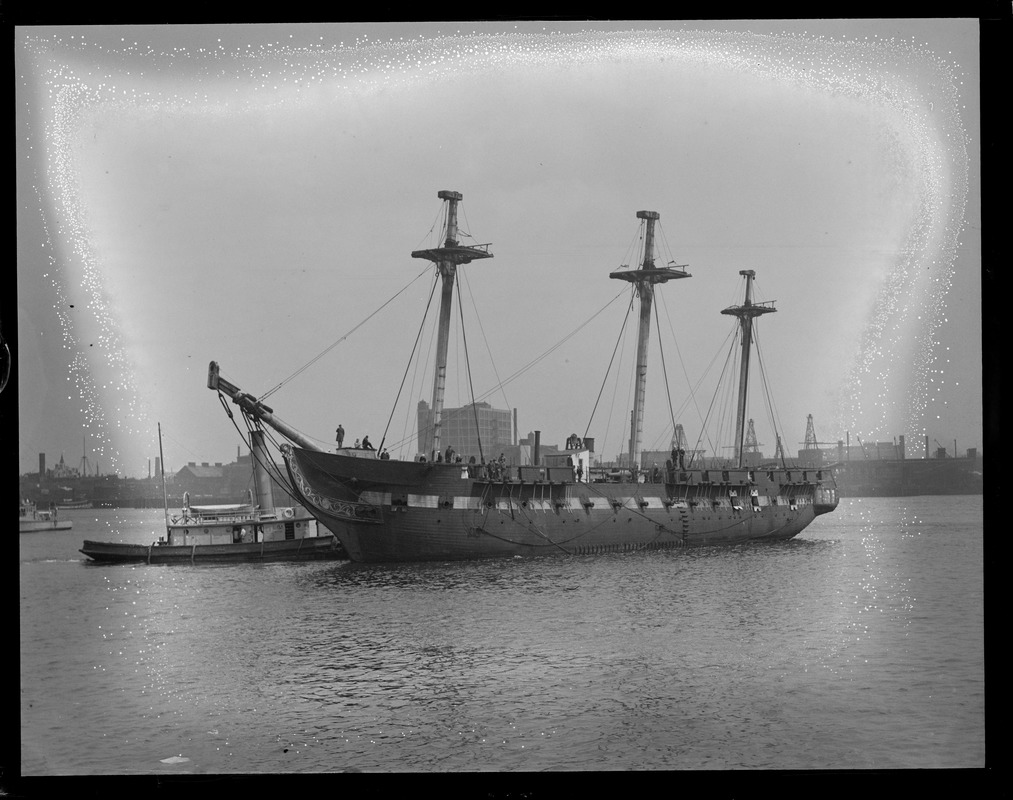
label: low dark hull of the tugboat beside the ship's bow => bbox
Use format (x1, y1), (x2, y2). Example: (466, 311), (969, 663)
(81, 536), (345, 564)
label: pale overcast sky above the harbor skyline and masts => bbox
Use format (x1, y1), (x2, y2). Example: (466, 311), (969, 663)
(15, 19), (983, 477)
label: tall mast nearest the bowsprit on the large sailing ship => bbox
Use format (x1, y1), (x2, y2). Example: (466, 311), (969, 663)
(411, 189), (492, 460)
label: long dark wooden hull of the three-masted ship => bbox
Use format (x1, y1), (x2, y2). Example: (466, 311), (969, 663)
(286, 448), (837, 562)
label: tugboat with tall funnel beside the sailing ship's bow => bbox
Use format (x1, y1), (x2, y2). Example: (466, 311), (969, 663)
(81, 430), (346, 564)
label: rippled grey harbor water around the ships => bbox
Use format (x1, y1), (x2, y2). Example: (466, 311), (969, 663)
(19, 495), (985, 777)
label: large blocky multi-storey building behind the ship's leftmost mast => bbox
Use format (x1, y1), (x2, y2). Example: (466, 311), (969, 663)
(418, 400), (516, 461)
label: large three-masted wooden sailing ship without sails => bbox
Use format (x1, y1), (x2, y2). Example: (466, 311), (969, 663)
(208, 190), (838, 562)
